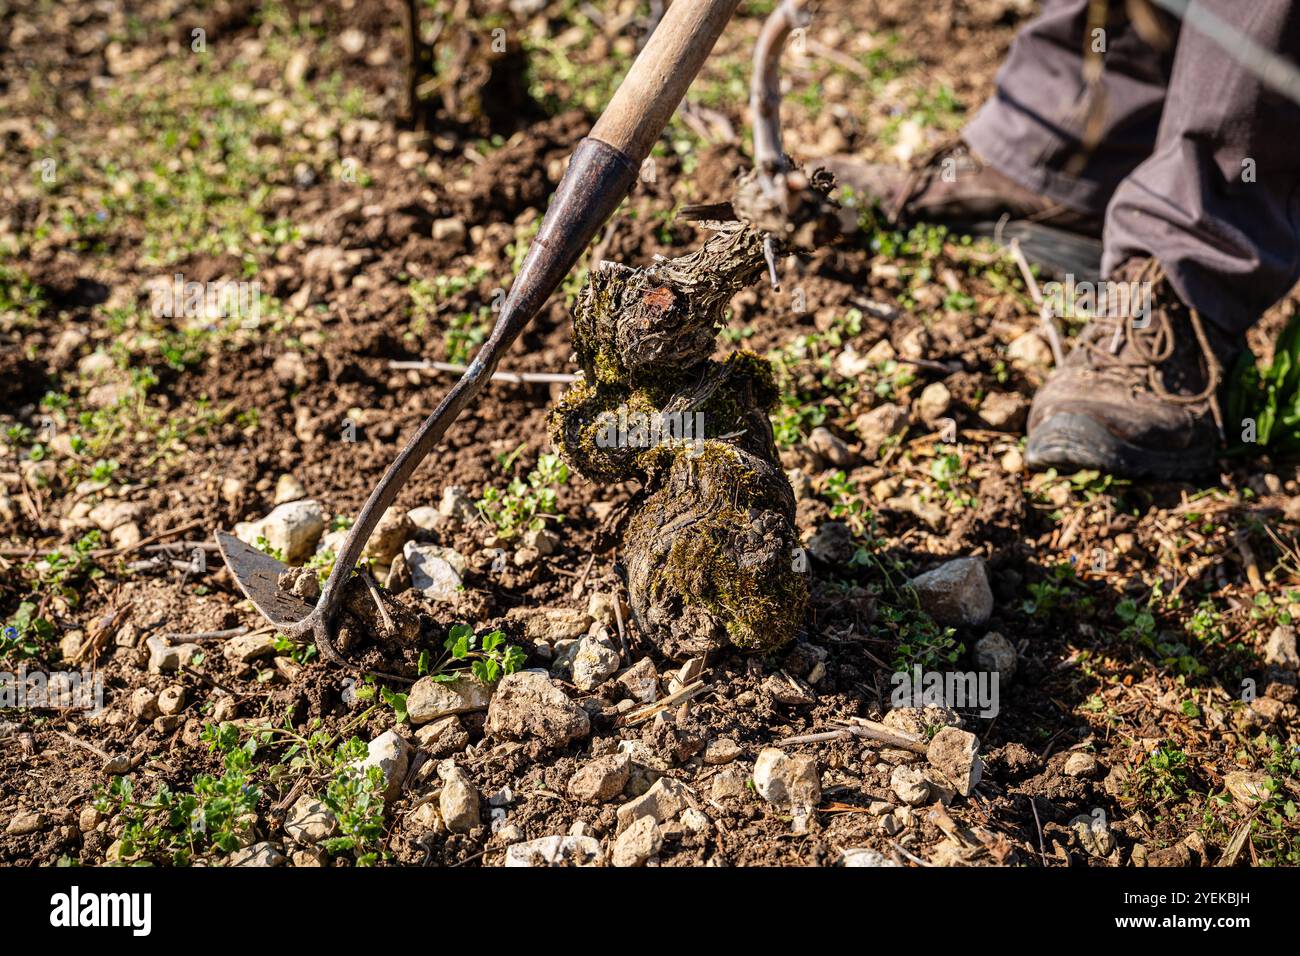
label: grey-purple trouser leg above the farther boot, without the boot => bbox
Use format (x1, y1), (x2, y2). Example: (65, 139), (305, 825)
(962, 0), (1177, 217)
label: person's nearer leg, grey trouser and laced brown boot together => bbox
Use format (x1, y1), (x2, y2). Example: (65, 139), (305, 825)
(1026, 0), (1300, 477)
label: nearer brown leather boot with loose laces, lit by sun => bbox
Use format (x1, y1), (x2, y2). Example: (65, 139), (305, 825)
(1024, 259), (1245, 479)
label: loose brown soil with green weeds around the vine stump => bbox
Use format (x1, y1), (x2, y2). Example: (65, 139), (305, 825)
(0, 0), (1300, 866)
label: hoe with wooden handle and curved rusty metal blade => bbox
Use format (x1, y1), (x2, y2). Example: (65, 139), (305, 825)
(216, 0), (740, 663)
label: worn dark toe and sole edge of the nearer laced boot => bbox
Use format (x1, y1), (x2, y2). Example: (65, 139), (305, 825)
(1024, 412), (1217, 480)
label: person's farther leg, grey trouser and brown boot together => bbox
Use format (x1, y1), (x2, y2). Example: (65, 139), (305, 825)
(823, 0), (1177, 278)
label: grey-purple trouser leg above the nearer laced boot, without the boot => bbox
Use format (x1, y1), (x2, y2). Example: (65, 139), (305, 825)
(1102, 0), (1300, 332)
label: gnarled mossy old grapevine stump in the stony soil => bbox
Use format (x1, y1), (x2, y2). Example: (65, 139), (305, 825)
(551, 222), (807, 658)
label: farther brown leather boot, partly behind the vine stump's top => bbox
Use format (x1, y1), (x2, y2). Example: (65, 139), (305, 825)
(819, 140), (1101, 238)
